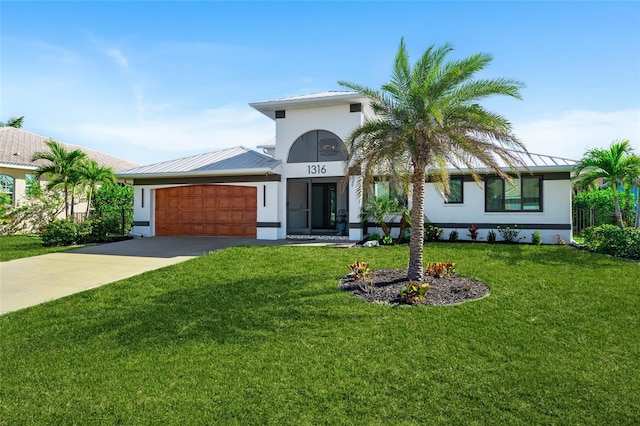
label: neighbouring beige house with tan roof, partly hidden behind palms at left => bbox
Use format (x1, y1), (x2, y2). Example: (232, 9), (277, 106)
(0, 127), (137, 213)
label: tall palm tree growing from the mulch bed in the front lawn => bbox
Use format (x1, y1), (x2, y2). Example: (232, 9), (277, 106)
(340, 39), (526, 281)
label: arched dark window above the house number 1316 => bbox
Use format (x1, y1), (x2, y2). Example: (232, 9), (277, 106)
(287, 130), (347, 163)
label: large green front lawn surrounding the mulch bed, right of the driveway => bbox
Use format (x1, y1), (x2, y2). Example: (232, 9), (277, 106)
(0, 243), (640, 425)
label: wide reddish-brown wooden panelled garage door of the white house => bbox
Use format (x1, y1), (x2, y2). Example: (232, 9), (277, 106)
(156, 185), (257, 238)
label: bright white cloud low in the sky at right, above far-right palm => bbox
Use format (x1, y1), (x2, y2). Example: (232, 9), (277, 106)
(513, 109), (640, 159)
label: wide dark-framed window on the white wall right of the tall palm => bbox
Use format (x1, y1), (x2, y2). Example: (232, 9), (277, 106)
(484, 176), (542, 212)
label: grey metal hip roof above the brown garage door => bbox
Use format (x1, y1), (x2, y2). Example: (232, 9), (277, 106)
(118, 146), (280, 178)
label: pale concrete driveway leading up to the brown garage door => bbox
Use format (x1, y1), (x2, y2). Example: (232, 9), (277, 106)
(0, 237), (287, 314)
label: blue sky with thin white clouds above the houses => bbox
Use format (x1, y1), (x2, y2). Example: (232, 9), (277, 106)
(0, 0), (640, 164)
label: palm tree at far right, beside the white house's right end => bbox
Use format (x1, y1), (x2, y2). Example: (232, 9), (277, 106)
(574, 140), (639, 228)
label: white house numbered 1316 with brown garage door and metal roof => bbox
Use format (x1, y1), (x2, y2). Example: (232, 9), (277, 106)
(118, 92), (575, 243)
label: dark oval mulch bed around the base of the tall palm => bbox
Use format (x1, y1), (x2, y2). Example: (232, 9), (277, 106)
(339, 269), (491, 306)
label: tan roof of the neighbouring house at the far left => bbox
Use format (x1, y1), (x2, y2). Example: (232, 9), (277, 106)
(0, 127), (138, 171)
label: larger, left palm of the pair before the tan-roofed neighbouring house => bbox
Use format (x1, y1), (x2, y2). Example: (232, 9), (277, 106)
(31, 139), (87, 218)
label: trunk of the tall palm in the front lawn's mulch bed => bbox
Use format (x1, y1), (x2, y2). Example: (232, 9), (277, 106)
(407, 164), (424, 281)
